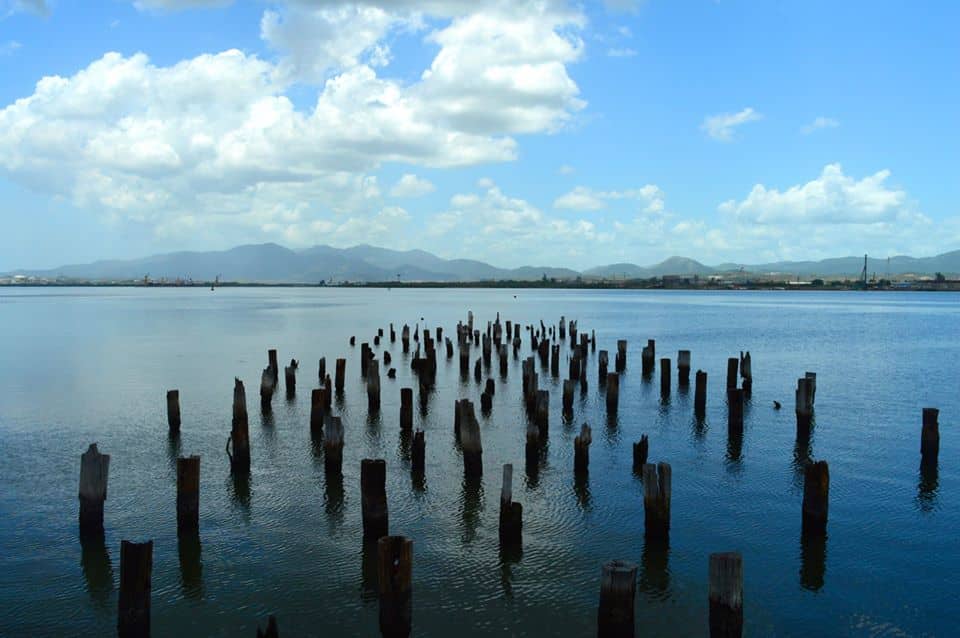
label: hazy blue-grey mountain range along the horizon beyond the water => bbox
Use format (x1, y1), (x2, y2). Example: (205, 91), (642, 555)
(7, 244), (960, 283)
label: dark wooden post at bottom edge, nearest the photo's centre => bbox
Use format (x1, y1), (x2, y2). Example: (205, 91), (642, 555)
(377, 536), (413, 638)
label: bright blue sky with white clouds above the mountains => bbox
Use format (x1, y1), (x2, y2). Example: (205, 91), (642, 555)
(0, 0), (960, 271)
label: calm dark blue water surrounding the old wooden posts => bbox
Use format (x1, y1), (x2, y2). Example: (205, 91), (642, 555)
(0, 288), (960, 637)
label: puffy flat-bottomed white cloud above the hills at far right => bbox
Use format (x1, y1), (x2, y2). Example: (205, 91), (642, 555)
(720, 164), (916, 225)
